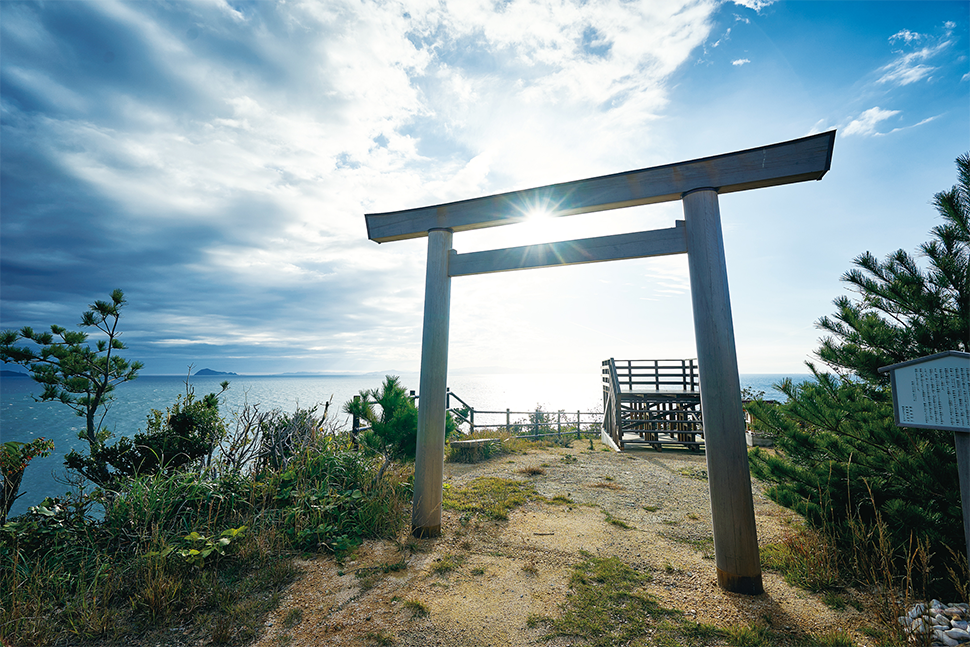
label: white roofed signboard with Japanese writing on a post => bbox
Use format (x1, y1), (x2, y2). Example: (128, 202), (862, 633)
(879, 350), (970, 563)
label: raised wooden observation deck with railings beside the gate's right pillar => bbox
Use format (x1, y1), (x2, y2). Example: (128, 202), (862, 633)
(603, 358), (704, 451)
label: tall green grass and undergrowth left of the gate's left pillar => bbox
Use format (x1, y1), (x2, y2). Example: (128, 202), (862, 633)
(0, 433), (411, 647)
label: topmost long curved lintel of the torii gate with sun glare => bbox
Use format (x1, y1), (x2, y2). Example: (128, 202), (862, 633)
(364, 130), (835, 243)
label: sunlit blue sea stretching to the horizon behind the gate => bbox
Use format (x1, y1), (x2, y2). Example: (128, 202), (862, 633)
(0, 371), (810, 516)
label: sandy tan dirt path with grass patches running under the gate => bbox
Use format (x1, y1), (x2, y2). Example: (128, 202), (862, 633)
(250, 440), (867, 647)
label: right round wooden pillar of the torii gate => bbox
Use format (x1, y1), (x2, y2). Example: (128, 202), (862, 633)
(683, 189), (764, 595)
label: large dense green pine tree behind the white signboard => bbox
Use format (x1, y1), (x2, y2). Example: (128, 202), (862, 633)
(749, 154), (970, 576)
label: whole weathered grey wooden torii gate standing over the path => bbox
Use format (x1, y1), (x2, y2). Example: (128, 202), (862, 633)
(365, 130), (835, 595)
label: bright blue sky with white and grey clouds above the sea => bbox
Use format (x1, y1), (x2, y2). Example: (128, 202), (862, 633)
(0, 0), (970, 374)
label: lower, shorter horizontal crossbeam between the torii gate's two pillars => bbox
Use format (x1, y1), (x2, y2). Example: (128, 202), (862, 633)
(448, 220), (687, 276)
